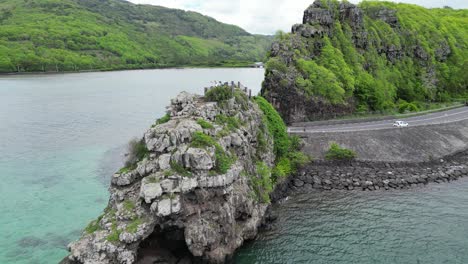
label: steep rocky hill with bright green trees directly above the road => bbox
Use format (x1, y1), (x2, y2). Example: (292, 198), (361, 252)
(262, 0), (468, 122)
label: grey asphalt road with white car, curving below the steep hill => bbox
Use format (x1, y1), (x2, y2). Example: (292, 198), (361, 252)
(288, 107), (468, 133)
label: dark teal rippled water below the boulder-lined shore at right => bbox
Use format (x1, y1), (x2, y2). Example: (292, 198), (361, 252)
(234, 179), (468, 264)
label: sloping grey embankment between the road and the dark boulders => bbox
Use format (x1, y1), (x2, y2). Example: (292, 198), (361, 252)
(298, 120), (468, 162)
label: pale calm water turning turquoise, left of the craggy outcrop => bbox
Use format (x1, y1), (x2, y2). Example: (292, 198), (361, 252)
(0, 69), (263, 264)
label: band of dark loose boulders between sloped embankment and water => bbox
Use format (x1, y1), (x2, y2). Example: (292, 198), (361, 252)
(284, 151), (468, 194)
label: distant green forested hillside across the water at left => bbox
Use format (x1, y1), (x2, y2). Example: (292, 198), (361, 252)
(0, 0), (272, 72)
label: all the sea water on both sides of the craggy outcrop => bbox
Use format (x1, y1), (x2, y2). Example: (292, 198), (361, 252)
(0, 69), (468, 264)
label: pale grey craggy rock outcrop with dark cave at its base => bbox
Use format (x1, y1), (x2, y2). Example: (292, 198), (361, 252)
(63, 89), (275, 264)
